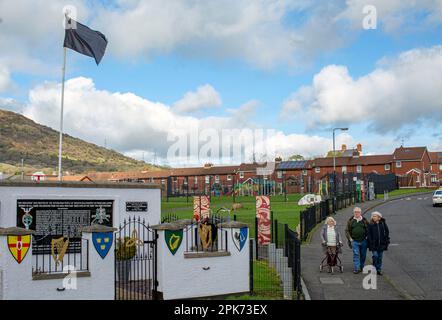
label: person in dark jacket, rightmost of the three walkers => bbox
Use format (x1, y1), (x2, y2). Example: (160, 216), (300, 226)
(367, 211), (390, 275)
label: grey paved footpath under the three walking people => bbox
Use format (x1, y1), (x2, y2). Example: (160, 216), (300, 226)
(301, 196), (414, 300)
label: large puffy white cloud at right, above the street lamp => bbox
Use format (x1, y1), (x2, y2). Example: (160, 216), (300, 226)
(281, 46), (442, 132)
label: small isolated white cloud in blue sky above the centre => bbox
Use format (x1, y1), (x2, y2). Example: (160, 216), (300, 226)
(173, 84), (222, 112)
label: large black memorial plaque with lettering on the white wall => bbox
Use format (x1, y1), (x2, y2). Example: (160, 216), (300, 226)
(17, 199), (114, 254)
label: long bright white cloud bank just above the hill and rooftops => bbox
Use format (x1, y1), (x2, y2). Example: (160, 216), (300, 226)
(23, 77), (352, 166)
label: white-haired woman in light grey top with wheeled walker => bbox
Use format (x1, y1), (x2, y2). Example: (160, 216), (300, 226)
(321, 217), (342, 272)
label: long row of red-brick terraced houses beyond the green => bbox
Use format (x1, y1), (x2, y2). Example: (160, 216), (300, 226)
(76, 144), (442, 196)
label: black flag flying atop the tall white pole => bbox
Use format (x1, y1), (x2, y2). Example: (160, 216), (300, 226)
(64, 18), (107, 65)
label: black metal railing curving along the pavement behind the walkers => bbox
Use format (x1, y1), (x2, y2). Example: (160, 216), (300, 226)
(300, 192), (360, 241)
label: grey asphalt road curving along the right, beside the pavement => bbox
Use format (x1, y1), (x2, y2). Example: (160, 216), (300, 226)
(375, 195), (442, 299)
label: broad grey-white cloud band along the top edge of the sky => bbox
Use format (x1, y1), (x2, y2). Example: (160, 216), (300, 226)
(0, 0), (442, 75)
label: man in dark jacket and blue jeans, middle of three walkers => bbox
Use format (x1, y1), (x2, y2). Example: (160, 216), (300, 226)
(345, 207), (368, 274)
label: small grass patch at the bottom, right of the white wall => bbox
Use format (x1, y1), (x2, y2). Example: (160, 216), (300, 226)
(226, 261), (284, 300)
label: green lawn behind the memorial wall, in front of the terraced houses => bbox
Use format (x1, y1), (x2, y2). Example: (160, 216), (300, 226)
(161, 194), (304, 238)
